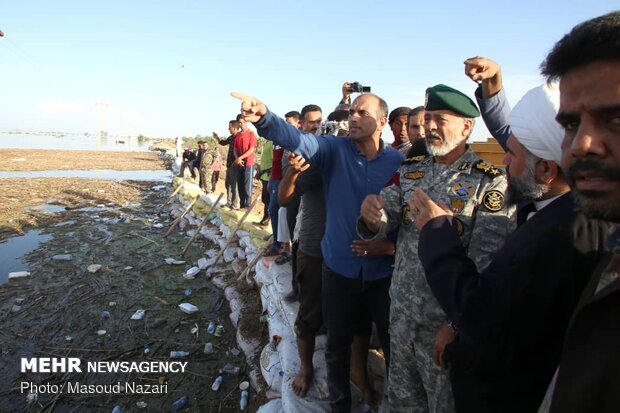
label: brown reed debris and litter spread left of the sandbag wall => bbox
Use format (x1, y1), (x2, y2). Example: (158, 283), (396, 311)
(0, 151), (266, 412)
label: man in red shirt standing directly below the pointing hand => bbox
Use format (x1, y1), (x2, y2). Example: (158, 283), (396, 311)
(233, 115), (256, 208)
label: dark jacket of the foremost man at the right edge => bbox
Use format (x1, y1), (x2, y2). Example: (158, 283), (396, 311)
(551, 229), (620, 413)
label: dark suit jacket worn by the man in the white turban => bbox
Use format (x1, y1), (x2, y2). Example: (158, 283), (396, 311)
(418, 193), (609, 413)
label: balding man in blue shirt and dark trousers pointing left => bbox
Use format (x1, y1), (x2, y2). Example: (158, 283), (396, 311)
(232, 93), (402, 412)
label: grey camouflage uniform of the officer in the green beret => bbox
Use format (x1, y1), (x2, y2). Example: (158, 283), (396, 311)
(360, 147), (514, 413)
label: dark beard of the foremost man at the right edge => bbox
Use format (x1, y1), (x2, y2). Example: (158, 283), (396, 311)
(566, 159), (620, 222)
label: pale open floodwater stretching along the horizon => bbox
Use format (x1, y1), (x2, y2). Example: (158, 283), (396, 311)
(0, 132), (152, 152)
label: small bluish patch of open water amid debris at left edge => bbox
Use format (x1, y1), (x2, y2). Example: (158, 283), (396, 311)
(0, 229), (52, 284)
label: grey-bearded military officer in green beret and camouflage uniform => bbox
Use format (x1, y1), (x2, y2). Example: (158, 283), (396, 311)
(358, 84), (515, 413)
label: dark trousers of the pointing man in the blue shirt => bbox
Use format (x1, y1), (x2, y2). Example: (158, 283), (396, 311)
(323, 263), (391, 413)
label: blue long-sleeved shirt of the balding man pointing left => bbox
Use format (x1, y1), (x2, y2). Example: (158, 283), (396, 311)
(256, 108), (403, 281)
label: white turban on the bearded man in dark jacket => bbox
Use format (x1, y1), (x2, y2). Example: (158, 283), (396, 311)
(509, 83), (564, 165)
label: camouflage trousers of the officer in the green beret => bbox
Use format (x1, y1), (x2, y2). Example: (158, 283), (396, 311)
(388, 317), (454, 413)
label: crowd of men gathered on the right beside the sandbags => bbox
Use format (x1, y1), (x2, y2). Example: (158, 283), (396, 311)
(190, 12), (620, 413)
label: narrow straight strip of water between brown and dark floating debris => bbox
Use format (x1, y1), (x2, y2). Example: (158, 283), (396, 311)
(0, 169), (172, 182)
